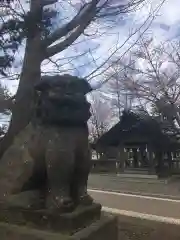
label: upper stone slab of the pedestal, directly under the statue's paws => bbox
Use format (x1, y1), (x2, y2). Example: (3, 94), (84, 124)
(0, 203), (101, 234)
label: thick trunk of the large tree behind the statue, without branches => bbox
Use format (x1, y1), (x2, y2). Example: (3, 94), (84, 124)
(0, 0), (43, 158)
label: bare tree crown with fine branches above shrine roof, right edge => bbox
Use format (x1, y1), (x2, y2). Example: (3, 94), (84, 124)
(106, 38), (180, 127)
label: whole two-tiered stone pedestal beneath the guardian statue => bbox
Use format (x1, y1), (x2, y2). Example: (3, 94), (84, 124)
(0, 203), (118, 240)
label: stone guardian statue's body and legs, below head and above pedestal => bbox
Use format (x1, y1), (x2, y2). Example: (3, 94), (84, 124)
(0, 124), (92, 211)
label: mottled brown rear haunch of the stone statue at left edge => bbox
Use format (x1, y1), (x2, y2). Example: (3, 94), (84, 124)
(0, 124), (34, 202)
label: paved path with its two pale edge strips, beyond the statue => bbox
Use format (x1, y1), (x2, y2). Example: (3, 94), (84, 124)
(89, 189), (180, 225)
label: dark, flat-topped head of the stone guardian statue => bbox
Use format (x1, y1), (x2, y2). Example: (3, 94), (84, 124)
(35, 75), (91, 126)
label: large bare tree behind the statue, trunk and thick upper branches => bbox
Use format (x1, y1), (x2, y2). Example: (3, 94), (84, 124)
(0, 0), (148, 158)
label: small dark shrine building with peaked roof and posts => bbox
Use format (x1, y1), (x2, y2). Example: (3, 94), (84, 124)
(96, 111), (180, 176)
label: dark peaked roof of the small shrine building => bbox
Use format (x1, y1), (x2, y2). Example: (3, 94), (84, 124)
(96, 110), (180, 148)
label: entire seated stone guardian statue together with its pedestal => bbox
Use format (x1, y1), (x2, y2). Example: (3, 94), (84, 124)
(0, 75), (111, 240)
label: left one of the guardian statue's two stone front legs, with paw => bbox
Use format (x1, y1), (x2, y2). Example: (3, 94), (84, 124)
(46, 136), (74, 212)
